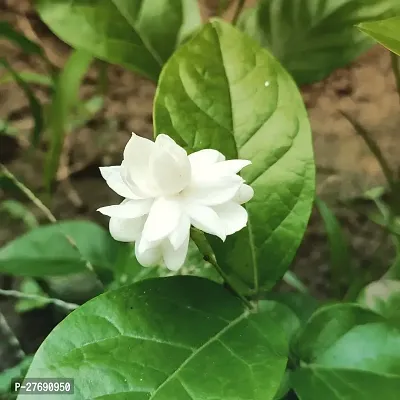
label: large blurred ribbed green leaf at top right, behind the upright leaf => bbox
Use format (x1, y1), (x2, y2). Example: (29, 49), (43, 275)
(239, 0), (400, 84)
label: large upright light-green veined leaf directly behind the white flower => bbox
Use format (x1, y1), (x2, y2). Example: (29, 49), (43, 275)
(154, 20), (314, 293)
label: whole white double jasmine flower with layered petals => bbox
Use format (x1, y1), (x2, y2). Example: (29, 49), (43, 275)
(98, 134), (254, 271)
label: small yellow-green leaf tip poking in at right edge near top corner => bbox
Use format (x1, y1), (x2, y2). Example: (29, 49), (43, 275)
(358, 17), (400, 55)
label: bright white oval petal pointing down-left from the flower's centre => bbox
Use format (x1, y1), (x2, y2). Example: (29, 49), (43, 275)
(143, 197), (183, 242)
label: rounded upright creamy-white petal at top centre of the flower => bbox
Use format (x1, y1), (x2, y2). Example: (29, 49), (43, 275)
(150, 134), (191, 195)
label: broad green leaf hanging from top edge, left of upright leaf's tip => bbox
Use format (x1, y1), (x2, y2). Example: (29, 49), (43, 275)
(37, 0), (201, 81)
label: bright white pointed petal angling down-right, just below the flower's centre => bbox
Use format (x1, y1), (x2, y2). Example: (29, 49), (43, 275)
(187, 204), (226, 241)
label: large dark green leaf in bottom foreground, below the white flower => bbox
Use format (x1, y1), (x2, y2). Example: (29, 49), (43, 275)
(18, 276), (287, 400)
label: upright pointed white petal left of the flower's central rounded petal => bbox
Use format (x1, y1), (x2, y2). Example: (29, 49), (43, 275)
(121, 133), (156, 195)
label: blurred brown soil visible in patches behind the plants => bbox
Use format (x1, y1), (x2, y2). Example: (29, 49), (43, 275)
(0, 0), (400, 368)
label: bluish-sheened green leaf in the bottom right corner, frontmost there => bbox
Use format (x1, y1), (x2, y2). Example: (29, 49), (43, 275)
(291, 323), (400, 400)
